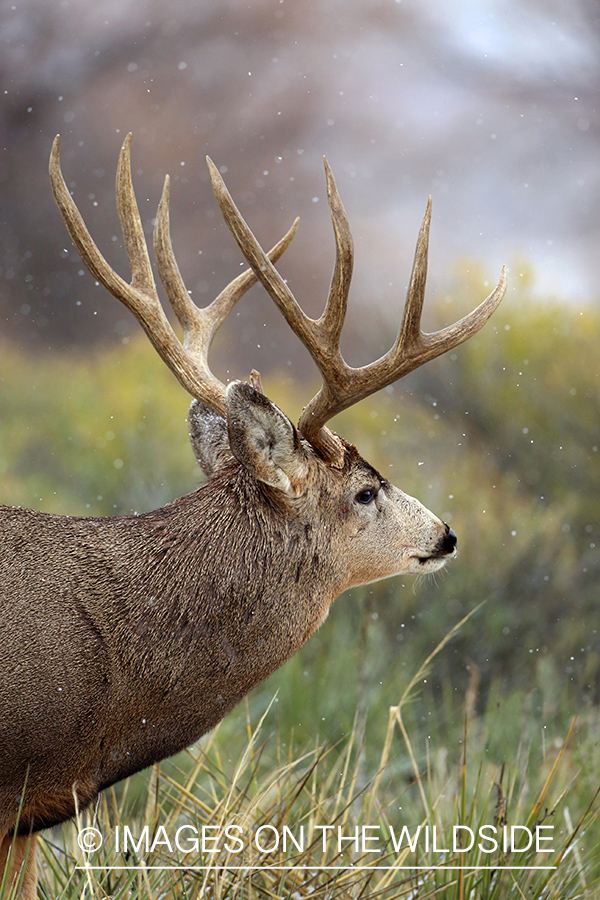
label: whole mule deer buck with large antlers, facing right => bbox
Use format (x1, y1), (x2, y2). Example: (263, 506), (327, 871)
(0, 136), (506, 900)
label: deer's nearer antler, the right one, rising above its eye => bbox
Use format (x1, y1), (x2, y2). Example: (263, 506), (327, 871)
(208, 159), (506, 465)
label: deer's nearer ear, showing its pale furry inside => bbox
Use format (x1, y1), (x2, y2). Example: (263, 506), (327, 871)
(226, 381), (306, 497)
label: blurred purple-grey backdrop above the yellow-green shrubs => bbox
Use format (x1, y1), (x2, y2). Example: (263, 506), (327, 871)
(0, 0), (600, 358)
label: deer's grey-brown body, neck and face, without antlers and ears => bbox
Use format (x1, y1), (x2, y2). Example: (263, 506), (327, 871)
(0, 401), (455, 834)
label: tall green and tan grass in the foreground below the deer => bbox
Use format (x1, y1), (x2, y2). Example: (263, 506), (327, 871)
(14, 623), (600, 900)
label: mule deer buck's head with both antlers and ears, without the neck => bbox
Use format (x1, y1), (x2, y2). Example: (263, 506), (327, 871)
(50, 135), (506, 587)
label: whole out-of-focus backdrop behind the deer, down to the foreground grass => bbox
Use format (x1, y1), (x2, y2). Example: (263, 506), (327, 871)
(0, 0), (600, 734)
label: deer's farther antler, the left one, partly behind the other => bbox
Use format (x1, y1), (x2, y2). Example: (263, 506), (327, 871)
(49, 134), (298, 415)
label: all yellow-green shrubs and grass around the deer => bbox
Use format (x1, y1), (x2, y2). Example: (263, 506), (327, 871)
(0, 290), (600, 900)
